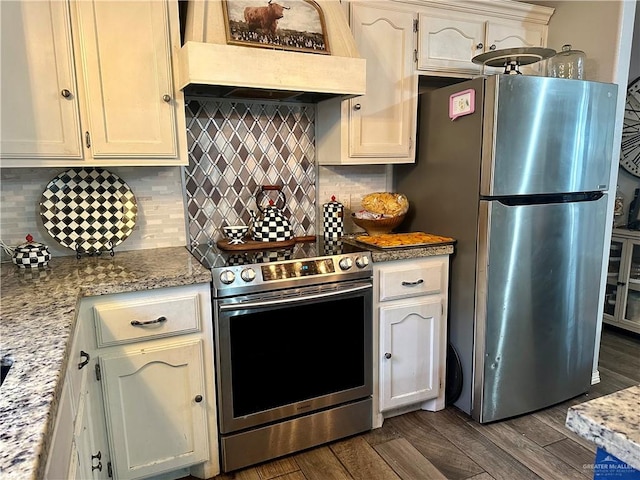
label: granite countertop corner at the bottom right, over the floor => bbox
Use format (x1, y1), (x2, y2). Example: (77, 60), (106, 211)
(566, 385), (640, 470)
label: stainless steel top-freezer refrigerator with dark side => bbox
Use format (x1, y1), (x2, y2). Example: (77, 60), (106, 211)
(393, 75), (617, 423)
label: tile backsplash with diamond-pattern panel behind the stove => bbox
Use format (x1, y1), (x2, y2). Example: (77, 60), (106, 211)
(0, 100), (387, 261)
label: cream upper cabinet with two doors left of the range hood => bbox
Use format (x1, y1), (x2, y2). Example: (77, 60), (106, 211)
(0, 0), (188, 167)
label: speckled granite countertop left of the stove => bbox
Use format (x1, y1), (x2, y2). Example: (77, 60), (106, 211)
(0, 247), (211, 480)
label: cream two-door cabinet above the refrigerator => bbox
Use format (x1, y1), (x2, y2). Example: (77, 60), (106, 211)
(417, 1), (554, 78)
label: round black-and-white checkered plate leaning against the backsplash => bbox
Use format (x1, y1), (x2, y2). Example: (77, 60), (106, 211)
(40, 168), (138, 254)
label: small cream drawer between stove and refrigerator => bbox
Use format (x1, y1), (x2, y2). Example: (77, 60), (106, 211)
(379, 259), (446, 301)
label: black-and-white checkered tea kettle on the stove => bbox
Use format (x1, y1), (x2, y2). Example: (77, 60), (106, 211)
(251, 185), (293, 242)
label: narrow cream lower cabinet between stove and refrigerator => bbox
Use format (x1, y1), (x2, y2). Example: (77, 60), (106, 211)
(373, 255), (449, 427)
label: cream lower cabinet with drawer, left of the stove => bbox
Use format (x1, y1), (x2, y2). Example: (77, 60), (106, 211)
(48, 284), (220, 480)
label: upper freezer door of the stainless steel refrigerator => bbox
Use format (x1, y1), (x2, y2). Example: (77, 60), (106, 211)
(480, 75), (617, 197)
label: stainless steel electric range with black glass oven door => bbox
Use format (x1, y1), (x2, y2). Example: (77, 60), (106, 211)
(192, 238), (373, 472)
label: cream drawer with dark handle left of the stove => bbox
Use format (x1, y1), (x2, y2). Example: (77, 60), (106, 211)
(93, 294), (200, 348)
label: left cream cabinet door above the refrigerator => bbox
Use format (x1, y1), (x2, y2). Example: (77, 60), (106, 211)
(418, 10), (485, 74)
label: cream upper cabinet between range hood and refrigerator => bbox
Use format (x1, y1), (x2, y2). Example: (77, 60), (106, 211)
(316, 1), (418, 165)
